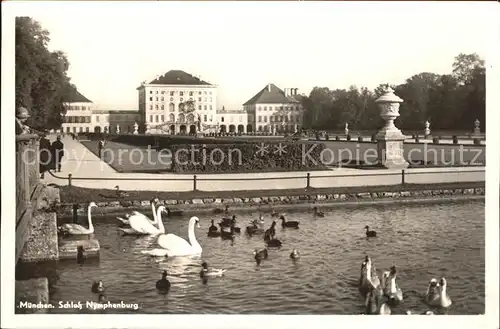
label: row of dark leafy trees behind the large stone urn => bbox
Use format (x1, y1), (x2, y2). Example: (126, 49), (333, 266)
(303, 54), (486, 130)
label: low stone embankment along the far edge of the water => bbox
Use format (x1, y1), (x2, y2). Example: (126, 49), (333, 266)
(58, 187), (485, 219)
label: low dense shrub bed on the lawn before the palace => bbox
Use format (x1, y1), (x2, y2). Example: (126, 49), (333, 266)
(170, 142), (325, 173)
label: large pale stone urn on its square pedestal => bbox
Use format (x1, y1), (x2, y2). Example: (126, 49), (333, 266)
(375, 88), (409, 169)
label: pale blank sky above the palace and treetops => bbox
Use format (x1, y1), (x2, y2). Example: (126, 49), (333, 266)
(2, 1), (498, 110)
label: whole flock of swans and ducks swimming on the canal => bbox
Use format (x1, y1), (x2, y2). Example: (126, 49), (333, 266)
(59, 198), (451, 315)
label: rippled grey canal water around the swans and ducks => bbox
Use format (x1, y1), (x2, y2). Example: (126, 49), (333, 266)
(19, 201), (485, 314)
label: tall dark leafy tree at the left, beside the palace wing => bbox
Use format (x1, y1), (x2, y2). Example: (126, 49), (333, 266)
(15, 17), (71, 130)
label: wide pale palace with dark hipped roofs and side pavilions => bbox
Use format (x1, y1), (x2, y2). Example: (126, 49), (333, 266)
(62, 70), (303, 134)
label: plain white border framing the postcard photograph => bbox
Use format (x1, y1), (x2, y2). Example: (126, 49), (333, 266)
(0, 1), (500, 329)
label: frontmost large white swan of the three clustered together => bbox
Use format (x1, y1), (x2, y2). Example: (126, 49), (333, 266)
(157, 217), (202, 257)
